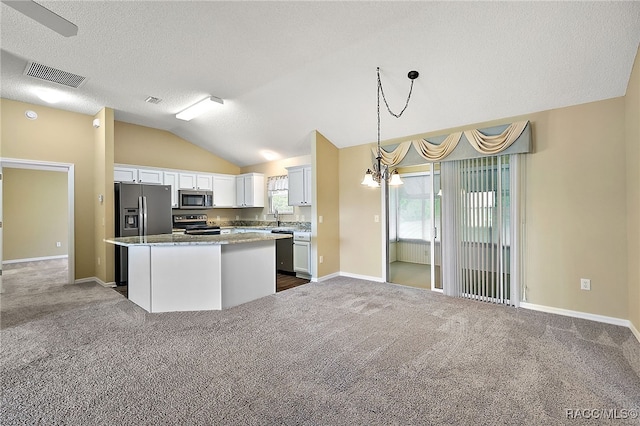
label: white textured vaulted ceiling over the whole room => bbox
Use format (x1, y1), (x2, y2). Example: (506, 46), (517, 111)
(0, 1), (640, 166)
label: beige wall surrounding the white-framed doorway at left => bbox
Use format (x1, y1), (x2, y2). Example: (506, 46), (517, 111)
(0, 99), (95, 279)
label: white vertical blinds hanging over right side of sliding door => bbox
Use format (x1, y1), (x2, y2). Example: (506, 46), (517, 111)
(441, 155), (520, 306)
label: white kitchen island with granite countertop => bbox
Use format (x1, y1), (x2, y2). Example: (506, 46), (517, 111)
(105, 233), (291, 312)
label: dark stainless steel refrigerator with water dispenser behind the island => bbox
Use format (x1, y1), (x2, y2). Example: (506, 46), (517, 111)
(115, 182), (172, 285)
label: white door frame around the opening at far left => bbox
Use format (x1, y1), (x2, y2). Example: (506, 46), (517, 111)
(0, 157), (76, 291)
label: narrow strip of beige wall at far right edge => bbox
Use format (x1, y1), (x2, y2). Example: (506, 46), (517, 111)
(625, 45), (640, 331)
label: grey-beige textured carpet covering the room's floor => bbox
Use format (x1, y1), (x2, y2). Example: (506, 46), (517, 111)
(0, 268), (640, 425)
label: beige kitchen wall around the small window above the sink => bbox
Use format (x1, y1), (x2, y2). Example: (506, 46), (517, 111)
(239, 155), (311, 222)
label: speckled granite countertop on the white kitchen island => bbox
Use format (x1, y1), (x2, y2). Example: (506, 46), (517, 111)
(104, 232), (292, 247)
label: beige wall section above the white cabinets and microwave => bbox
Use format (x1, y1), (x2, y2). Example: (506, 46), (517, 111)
(114, 121), (240, 175)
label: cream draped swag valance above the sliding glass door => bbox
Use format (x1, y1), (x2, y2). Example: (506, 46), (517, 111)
(372, 120), (529, 167)
